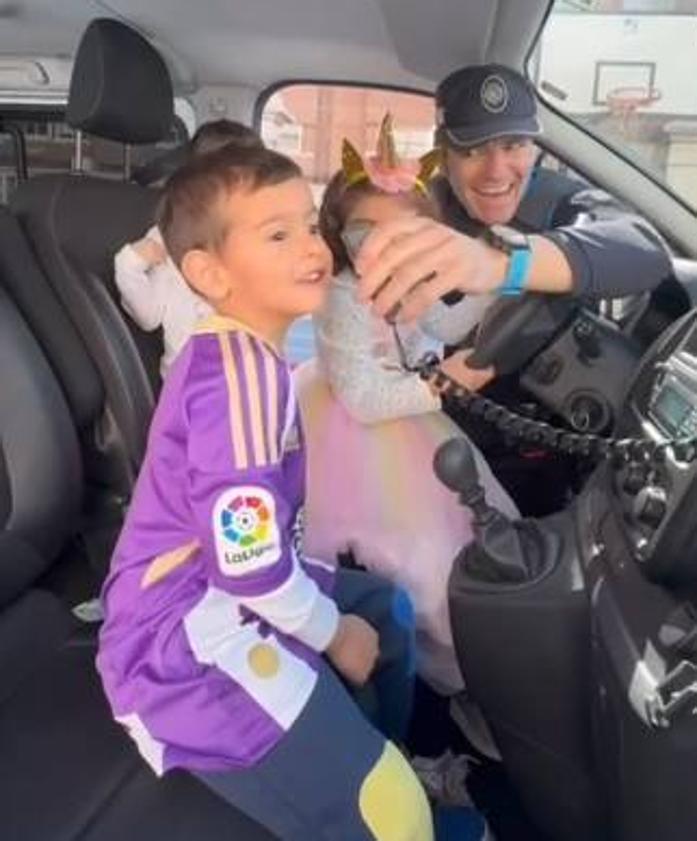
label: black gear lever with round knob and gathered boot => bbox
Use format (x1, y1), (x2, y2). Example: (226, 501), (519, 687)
(433, 437), (559, 584)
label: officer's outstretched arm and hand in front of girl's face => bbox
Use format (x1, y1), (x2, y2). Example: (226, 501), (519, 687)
(357, 213), (670, 321)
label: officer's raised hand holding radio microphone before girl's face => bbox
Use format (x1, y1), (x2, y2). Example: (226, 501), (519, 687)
(356, 217), (508, 321)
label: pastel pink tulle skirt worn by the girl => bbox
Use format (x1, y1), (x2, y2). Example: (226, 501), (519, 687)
(295, 361), (517, 693)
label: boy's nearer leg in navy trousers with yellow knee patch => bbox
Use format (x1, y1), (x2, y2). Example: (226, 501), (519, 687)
(196, 664), (433, 841)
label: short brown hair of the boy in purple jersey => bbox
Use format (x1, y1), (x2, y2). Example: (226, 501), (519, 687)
(157, 144), (302, 267)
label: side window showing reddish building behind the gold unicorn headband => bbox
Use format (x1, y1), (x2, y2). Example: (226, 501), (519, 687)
(258, 84), (435, 364)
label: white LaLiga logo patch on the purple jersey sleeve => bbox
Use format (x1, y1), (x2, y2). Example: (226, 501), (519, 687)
(213, 486), (281, 576)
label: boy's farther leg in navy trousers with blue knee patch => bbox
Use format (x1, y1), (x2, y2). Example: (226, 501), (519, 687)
(333, 569), (416, 742)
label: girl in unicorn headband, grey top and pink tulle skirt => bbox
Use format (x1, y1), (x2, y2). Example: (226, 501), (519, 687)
(295, 115), (517, 695)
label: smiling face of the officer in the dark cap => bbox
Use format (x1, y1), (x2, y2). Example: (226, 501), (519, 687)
(445, 137), (537, 225)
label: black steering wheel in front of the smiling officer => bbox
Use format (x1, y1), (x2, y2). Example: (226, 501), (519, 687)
(467, 293), (580, 376)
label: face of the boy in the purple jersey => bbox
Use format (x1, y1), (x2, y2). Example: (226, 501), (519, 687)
(190, 178), (332, 331)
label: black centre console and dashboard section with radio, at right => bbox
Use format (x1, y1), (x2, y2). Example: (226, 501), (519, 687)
(446, 311), (697, 841)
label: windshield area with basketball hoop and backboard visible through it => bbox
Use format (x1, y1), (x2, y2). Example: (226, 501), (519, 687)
(529, 0), (697, 209)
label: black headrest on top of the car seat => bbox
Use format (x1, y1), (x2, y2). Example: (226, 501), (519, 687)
(65, 18), (174, 143)
